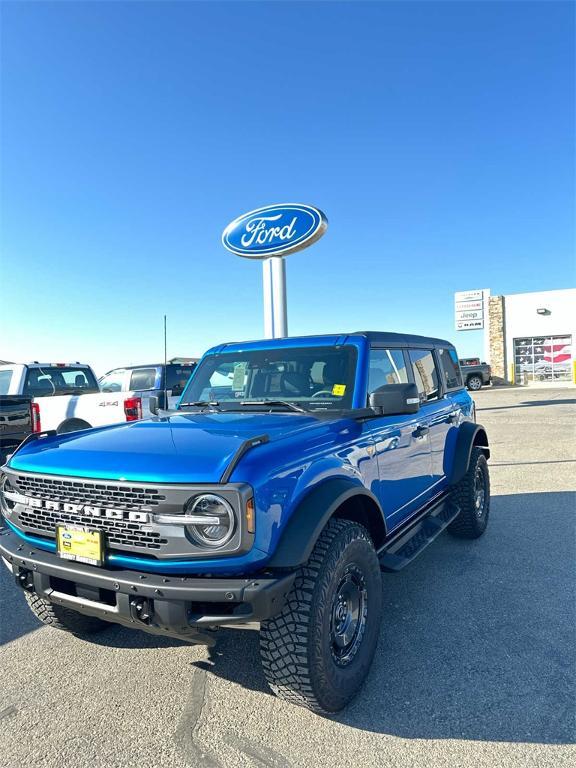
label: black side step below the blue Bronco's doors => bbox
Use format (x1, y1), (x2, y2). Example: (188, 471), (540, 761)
(379, 499), (460, 571)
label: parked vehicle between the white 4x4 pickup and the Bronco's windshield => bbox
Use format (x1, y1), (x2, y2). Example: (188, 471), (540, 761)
(99, 358), (198, 417)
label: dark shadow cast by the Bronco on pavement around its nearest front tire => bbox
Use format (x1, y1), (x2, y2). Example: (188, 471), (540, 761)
(189, 492), (576, 744)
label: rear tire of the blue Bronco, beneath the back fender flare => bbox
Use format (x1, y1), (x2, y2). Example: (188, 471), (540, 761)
(448, 448), (490, 539)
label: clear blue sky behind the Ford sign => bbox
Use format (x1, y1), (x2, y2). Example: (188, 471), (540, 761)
(0, 1), (575, 372)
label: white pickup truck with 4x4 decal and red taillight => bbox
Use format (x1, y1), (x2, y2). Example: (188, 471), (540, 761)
(0, 362), (142, 434)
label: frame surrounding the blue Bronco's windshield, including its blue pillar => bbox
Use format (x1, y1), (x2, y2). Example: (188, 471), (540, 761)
(177, 336), (367, 415)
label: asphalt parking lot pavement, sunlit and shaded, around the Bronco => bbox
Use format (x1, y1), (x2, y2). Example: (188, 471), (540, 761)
(0, 388), (576, 768)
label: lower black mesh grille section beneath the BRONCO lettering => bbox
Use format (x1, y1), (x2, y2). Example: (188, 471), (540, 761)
(18, 507), (168, 549)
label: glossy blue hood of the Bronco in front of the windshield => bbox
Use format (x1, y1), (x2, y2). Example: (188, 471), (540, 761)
(8, 412), (318, 483)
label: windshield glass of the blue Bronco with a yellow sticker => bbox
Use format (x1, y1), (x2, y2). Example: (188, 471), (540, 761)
(181, 346), (357, 410)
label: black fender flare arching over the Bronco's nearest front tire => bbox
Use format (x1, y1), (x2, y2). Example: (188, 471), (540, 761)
(267, 477), (386, 568)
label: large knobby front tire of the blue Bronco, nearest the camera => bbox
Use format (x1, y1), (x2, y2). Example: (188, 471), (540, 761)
(260, 519), (382, 714)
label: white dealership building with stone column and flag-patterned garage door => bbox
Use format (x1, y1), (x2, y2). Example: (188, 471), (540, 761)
(485, 288), (576, 384)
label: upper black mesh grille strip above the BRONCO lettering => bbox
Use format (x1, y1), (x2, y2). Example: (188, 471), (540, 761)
(18, 475), (166, 512)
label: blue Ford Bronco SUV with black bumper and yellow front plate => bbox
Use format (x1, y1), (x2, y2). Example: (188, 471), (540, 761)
(0, 332), (490, 712)
